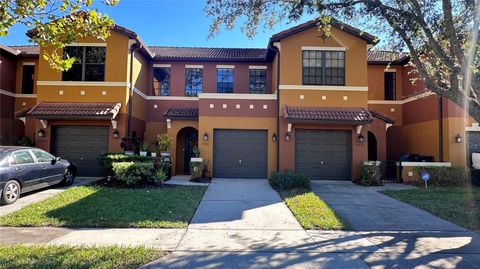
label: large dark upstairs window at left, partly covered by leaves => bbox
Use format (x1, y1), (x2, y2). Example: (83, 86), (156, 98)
(62, 46), (106, 81)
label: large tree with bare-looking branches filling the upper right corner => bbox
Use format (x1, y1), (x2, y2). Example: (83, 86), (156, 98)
(205, 0), (480, 122)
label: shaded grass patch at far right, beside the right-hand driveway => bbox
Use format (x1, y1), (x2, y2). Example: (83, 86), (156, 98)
(383, 187), (480, 231)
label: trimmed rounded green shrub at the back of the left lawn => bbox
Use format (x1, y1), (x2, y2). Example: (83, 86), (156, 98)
(112, 162), (155, 186)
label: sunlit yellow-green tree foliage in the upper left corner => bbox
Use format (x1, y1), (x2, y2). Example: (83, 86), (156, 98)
(0, 0), (119, 71)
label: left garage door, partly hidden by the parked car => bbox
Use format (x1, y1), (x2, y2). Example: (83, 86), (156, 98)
(53, 126), (109, 176)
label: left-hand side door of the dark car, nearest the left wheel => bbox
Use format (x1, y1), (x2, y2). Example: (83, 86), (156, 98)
(10, 149), (42, 191)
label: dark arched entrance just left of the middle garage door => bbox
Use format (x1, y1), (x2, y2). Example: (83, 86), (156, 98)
(175, 127), (198, 175)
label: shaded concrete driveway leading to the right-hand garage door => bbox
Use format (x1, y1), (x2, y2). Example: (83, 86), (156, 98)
(312, 180), (466, 231)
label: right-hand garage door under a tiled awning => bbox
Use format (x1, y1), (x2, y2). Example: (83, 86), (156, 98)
(295, 130), (351, 180)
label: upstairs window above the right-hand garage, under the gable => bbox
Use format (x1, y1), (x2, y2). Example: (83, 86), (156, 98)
(302, 50), (345, 85)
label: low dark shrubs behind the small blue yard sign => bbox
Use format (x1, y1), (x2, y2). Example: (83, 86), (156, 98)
(415, 166), (469, 186)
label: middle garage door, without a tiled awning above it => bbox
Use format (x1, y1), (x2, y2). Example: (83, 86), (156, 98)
(213, 130), (267, 178)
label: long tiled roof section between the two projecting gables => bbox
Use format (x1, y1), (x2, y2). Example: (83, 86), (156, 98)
(150, 46), (267, 61)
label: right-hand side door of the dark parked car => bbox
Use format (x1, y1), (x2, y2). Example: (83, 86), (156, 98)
(31, 149), (64, 185)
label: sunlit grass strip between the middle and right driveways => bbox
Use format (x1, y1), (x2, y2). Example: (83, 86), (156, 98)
(279, 188), (350, 230)
